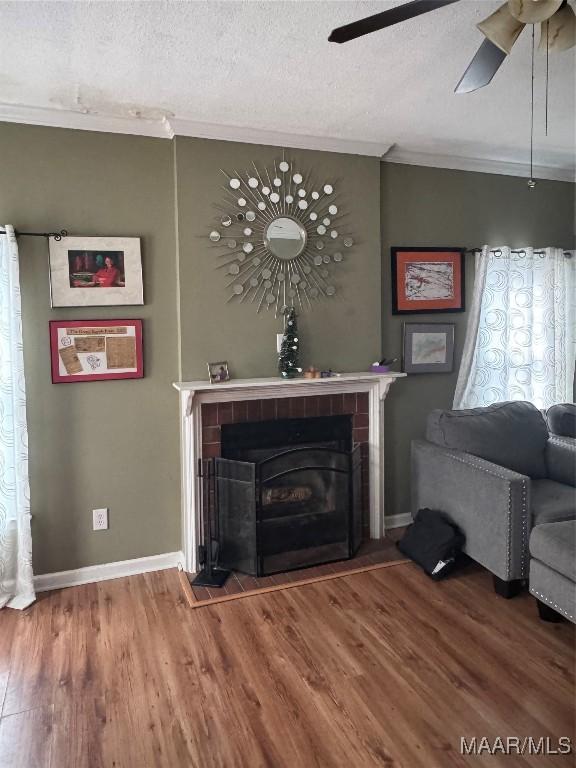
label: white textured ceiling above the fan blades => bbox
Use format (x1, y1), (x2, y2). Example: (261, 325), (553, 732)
(0, 0), (576, 168)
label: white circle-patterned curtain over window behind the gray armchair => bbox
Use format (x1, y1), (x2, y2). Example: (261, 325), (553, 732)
(454, 246), (576, 408)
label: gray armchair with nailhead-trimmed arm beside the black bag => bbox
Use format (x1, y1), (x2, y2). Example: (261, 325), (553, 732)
(412, 402), (576, 597)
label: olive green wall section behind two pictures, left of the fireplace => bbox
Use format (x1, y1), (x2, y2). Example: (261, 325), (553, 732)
(0, 123), (180, 573)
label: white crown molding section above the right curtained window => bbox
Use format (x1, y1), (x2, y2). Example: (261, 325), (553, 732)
(382, 146), (576, 182)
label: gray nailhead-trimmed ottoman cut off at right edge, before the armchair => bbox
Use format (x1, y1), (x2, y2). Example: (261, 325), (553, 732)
(530, 520), (576, 623)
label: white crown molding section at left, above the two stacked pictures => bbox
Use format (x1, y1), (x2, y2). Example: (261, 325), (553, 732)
(0, 104), (174, 139)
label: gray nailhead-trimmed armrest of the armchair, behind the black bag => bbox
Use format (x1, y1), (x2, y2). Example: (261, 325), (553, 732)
(412, 440), (530, 581)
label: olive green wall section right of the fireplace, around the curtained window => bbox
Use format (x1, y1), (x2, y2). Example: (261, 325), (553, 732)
(381, 163), (575, 515)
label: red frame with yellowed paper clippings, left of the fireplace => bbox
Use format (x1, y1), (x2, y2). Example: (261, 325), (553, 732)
(49, 320), (144, 384)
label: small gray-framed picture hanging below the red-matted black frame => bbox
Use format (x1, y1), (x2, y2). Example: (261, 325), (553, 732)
(402, 323), (455, 373)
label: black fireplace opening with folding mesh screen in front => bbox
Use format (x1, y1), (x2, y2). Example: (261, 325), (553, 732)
(211, 416), (362, 576)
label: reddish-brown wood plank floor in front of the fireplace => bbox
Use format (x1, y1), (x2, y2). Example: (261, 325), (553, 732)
(0, 564), (575, 768)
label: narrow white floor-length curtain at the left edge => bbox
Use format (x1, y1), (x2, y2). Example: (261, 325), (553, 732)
(0, 226), (35, 608)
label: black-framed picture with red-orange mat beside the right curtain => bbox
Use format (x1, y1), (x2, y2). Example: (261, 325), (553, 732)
(391, 248), (465, 315)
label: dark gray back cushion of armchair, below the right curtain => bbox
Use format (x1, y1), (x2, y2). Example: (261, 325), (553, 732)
(426, 400), (548, 478)
